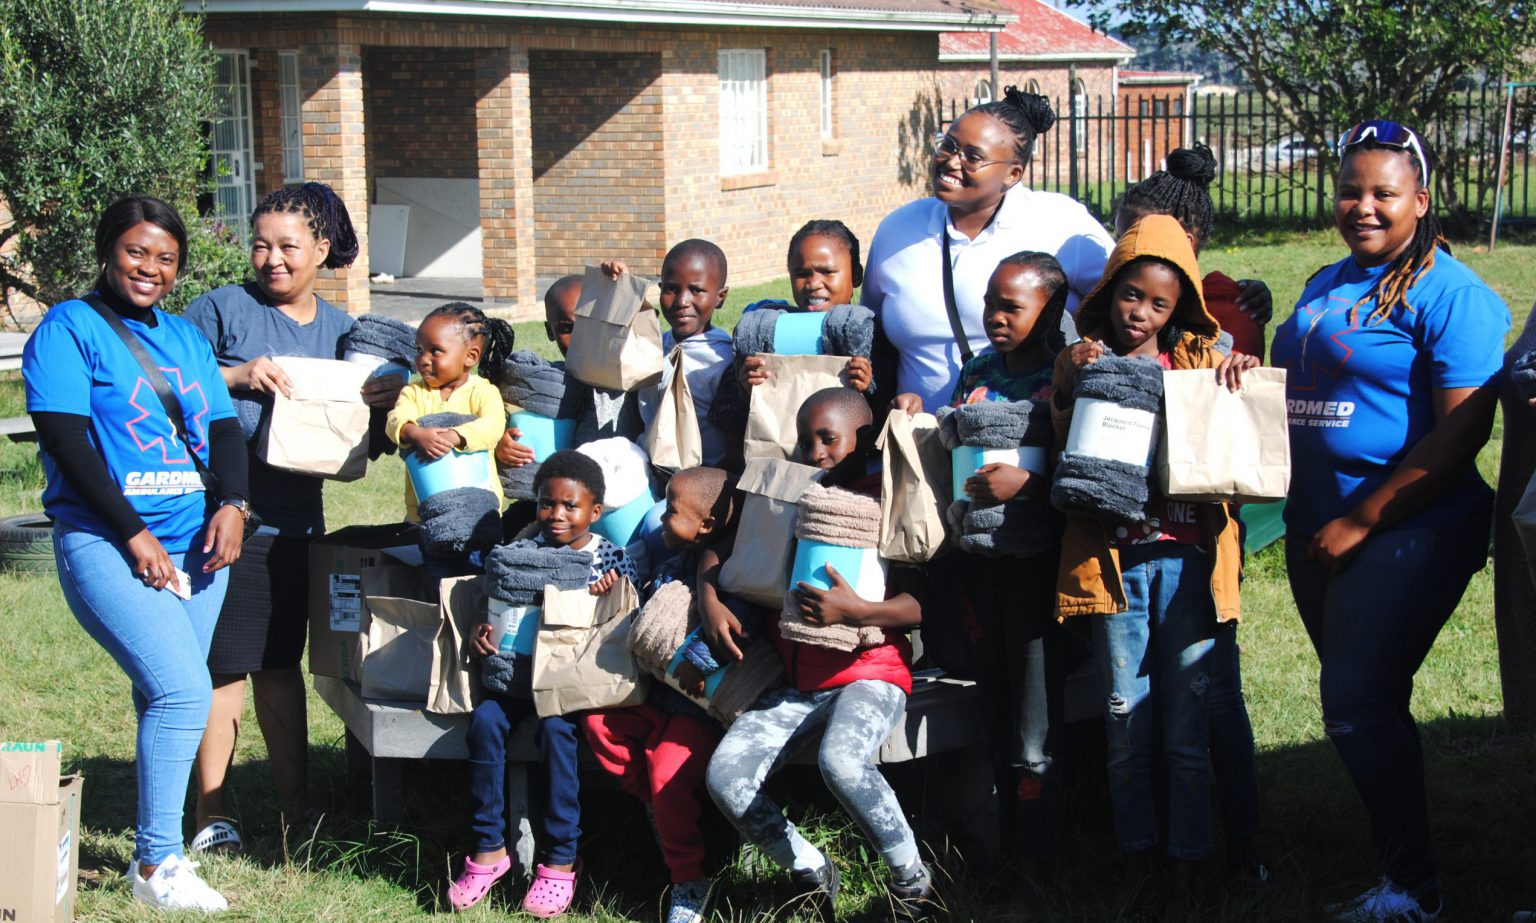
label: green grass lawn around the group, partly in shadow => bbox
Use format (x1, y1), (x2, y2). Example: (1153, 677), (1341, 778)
(0, 233), (1536, 923)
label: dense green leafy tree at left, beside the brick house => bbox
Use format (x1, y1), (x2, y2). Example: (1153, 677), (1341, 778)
(0, 0), (241, 316)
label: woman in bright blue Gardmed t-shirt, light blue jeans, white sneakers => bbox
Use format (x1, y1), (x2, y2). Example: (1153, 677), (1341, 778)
(22, 197), (250, 911)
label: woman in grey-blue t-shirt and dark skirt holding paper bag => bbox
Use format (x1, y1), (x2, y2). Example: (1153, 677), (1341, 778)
(186, 183), (406, 849)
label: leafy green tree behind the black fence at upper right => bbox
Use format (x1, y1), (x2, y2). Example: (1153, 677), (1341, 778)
(1091, 0), (1536, 218)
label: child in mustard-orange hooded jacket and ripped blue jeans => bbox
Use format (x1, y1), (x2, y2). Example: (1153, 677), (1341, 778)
(1052, 215), (1258, 923)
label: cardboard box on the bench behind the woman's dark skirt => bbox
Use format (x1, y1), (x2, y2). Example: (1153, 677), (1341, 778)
(309, 522), (416, 680)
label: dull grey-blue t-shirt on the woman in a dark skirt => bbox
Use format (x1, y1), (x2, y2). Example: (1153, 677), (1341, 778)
(181, 283), (355, 534)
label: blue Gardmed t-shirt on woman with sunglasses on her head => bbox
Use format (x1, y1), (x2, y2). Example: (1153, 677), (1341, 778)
(1272, 250), (1510, 536)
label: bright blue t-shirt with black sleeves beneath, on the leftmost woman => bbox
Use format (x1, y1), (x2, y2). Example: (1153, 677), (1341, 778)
(22, 299), (235, 553)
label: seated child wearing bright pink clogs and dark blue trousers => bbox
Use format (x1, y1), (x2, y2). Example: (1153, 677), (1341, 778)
(449, 452), (636, 917)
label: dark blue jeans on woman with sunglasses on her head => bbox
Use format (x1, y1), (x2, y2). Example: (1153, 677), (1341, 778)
(1286, 505), (1491, 891)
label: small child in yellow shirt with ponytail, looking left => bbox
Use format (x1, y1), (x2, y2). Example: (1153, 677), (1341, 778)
(384, 301), (513, 522)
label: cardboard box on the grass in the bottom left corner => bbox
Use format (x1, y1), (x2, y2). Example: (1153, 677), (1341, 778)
(0, 740), (84, 923)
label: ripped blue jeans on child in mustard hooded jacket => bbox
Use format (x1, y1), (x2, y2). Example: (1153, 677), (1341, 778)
(1091, 542), (1217, 860)
